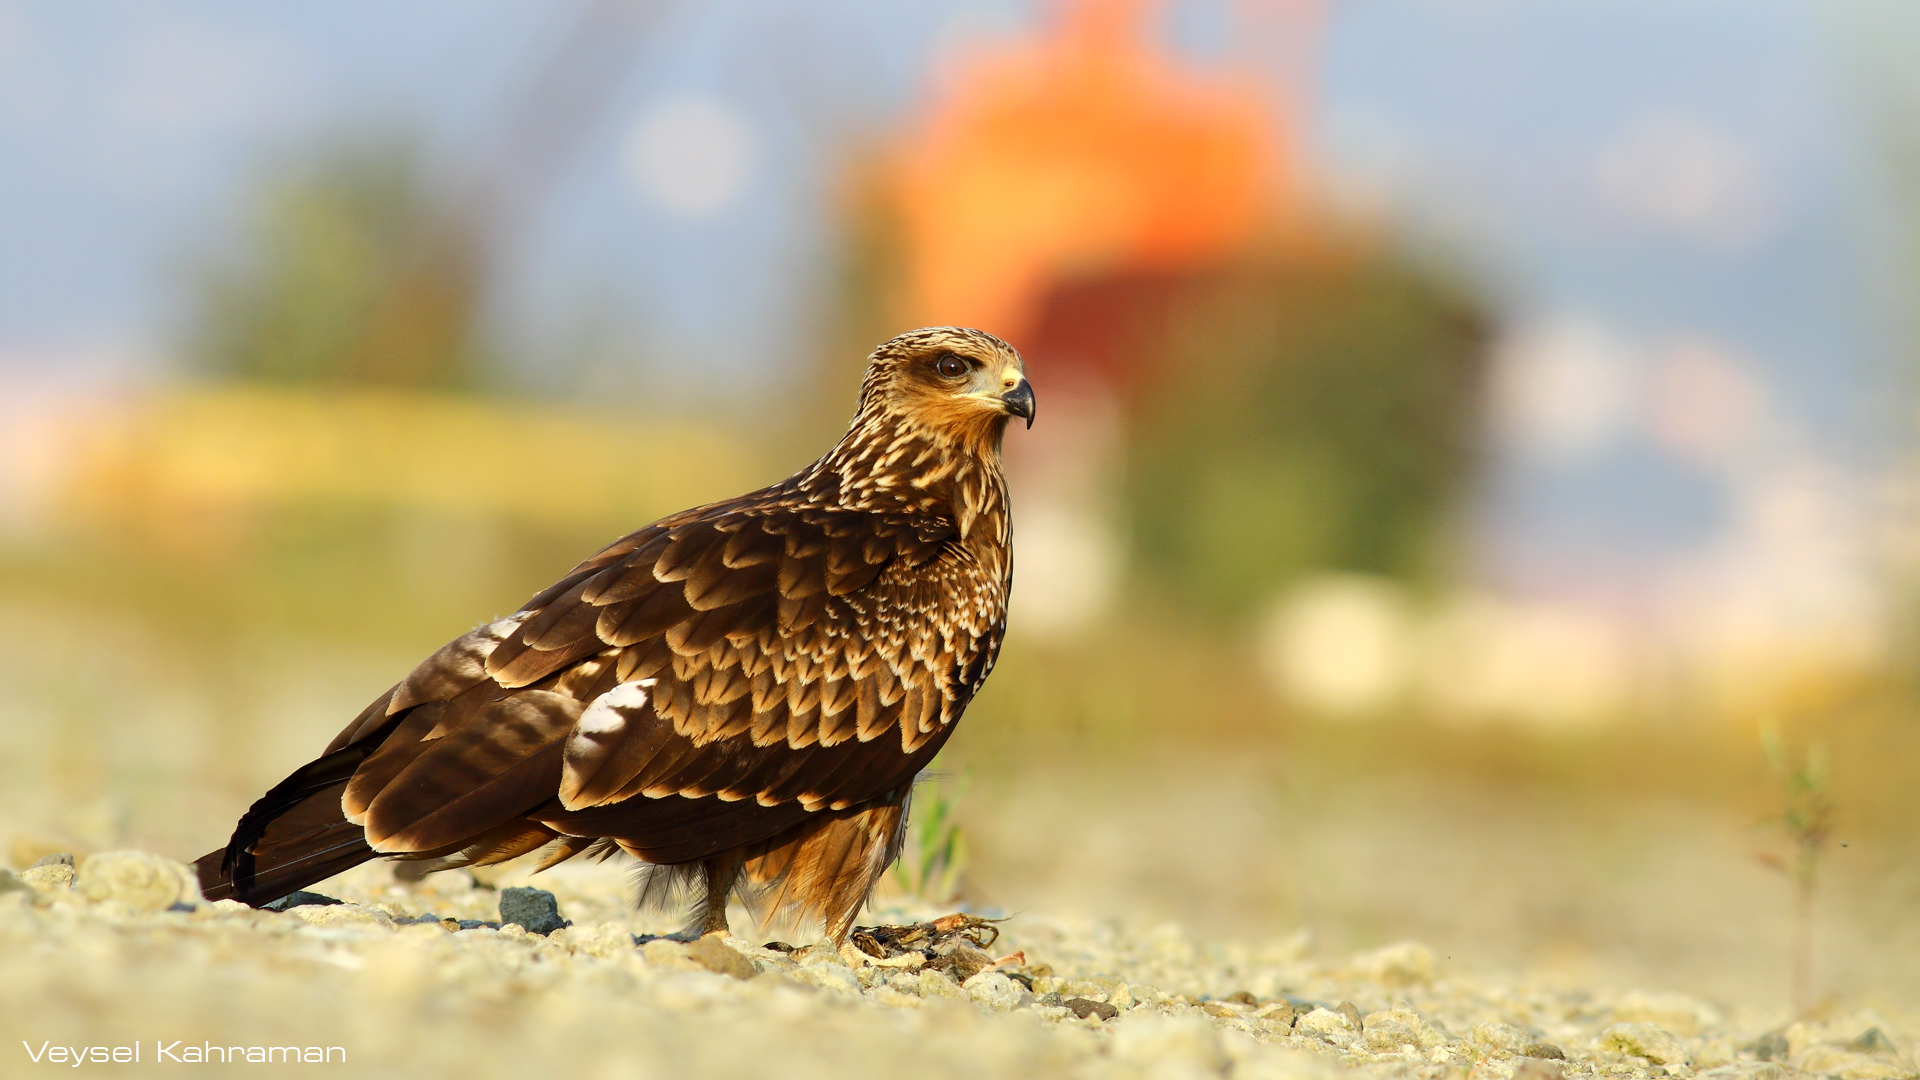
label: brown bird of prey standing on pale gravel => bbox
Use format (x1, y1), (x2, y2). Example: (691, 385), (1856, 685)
(196, 327), (1033, 951)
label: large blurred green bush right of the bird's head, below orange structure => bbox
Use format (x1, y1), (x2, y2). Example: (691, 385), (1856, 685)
(1129, 252), (1488, 615)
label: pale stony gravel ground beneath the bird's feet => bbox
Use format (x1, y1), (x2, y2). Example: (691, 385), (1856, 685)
(0, 851), (1916, 1080)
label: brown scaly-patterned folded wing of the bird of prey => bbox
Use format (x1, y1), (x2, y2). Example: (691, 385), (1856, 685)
(330, 488), (1002, 863)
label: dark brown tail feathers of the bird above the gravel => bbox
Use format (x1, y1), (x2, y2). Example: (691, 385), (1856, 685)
(194, 738), (382, 907)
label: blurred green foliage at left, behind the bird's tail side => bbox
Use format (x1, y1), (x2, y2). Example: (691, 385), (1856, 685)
(184, 136), (482, 390)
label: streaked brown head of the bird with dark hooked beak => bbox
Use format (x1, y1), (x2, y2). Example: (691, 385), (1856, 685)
(854, 327), (1033, 450)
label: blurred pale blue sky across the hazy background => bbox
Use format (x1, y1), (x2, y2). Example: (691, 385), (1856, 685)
(0, 0), (1905, 580)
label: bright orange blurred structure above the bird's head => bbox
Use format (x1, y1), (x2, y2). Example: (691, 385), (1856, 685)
(897, 0), (1298, 342)
